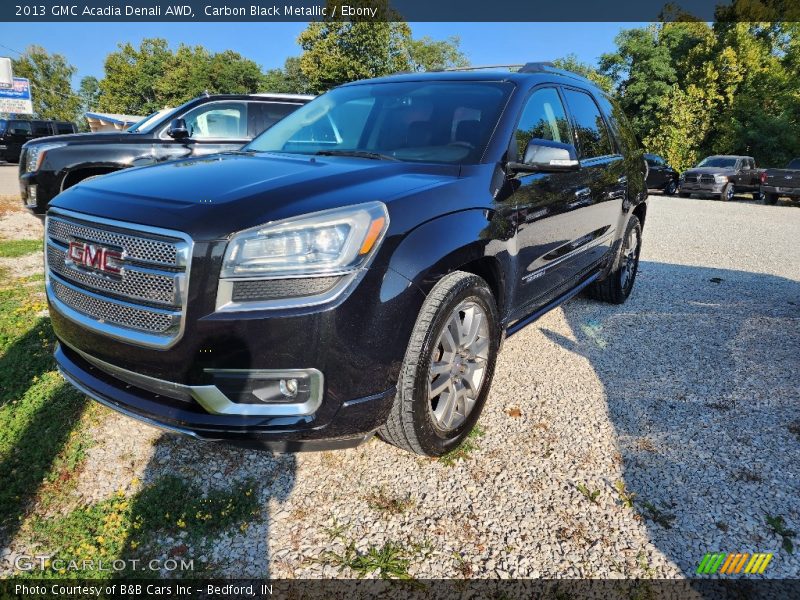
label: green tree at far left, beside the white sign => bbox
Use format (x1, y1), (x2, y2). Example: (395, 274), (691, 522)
(12, 46), (80, 121)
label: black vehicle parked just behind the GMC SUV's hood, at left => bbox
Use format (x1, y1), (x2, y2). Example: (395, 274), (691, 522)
(19, 94), (313, 214)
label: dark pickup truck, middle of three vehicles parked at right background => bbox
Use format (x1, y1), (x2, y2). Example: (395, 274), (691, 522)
(679, 155), (765, 200)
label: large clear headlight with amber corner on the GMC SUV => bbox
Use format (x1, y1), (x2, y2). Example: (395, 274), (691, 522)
(221, 202), (389, 278)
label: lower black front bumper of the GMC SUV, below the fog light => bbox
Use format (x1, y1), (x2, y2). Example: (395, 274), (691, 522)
(55, 344), (395, 452)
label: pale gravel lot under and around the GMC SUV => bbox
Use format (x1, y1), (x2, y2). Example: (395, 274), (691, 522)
(0, 186), (800, 578)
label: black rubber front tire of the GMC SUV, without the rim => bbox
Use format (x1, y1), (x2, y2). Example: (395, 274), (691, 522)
(378, 271), (500, 456)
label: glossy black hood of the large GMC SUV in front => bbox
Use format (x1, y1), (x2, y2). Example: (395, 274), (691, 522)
(50, 153), (459, 240)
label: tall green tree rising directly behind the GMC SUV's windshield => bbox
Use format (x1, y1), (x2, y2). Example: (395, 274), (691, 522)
(297, 0), (411, 92)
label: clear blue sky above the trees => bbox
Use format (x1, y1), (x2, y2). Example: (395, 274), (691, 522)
(0, 23), (641, 86)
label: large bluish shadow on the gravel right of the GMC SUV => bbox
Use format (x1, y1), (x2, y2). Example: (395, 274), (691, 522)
(542, 262), (800, 577)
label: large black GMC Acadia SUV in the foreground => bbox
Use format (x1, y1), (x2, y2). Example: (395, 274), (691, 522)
(46, 63), (647, 455)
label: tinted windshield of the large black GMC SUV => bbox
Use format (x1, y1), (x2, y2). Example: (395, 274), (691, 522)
(245, 81), (513, 164)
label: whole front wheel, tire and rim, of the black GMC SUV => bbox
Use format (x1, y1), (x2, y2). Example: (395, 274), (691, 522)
(378, 271), (500, 456)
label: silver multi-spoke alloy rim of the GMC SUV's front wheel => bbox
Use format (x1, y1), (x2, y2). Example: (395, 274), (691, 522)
(428, 300), (489, 432)
